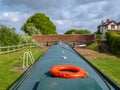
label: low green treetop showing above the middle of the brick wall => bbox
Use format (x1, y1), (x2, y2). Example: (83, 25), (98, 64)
(64, 29), (90, 34)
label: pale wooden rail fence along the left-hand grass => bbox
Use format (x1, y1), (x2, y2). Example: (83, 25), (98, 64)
(0, 44), (35, 54)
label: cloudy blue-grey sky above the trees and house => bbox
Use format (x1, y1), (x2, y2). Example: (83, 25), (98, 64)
(0, 0), (120, 34)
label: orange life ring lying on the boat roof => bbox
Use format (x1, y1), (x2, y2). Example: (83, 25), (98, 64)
(50, 65), (87, 78)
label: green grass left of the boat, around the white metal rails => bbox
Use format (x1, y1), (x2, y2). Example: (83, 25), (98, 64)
(0, 47), (45, 90)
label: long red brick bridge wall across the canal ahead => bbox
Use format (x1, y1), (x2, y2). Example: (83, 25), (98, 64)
(33, 34), (95, 45)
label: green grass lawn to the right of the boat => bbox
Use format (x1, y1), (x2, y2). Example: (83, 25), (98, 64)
(90, 58), (120, 86)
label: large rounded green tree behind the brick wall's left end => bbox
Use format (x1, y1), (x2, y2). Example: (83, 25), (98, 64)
(21, 13), (57, 35)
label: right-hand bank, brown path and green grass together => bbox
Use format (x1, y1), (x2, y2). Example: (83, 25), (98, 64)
(80, 49), (120, 86)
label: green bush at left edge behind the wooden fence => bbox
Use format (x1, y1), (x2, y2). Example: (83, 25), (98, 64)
(0, 25), (20, 46)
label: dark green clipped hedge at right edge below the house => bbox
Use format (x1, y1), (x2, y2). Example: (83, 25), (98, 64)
(106, 32), (120, 55)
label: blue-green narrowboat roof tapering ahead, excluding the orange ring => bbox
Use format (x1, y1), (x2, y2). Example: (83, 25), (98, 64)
(10, 42), (119, 90)
